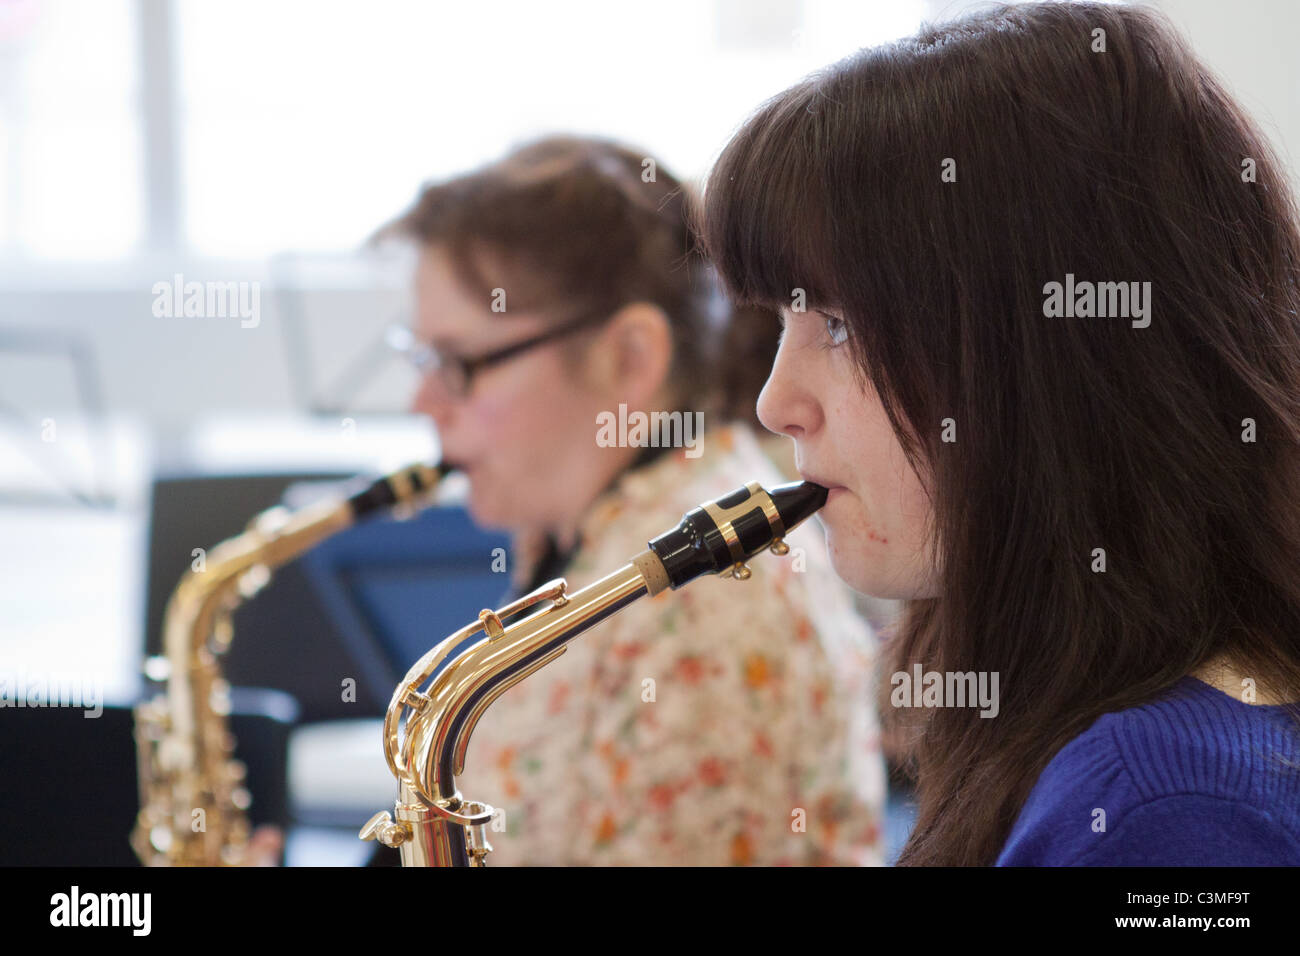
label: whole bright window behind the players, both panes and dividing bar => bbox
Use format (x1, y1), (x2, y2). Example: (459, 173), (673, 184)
(0, 0), (926, 259)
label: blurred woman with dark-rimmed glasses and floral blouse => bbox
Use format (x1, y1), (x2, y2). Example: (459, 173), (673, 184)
(371, 137), (884, 865)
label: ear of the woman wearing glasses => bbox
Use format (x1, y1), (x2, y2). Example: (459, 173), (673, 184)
(588, 302), (672, 405)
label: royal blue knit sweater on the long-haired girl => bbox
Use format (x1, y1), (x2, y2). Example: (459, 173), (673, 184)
(997, 678), (1300, 866)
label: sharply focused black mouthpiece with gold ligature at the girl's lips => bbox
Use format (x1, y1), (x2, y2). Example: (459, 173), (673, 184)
(649, 481), (827, 591)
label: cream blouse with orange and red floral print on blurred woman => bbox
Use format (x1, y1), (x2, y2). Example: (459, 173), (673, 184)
(458, 427), (885, 866)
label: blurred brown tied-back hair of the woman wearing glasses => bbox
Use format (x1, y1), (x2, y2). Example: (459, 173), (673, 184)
(376, 134), (780, 425)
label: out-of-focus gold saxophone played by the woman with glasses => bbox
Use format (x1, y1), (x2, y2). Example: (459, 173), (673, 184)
(131, 464), (450, 866)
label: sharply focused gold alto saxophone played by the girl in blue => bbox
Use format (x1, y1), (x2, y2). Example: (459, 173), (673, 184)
(359, 481), (827, 866)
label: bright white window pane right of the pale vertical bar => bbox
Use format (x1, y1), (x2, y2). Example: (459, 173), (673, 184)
(177, 0), (922, 255)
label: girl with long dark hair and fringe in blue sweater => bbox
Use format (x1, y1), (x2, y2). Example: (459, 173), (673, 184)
(705, 3), (1300, 865)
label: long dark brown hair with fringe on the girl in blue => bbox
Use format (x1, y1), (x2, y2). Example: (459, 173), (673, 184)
(703, 3), (1300, 865)
